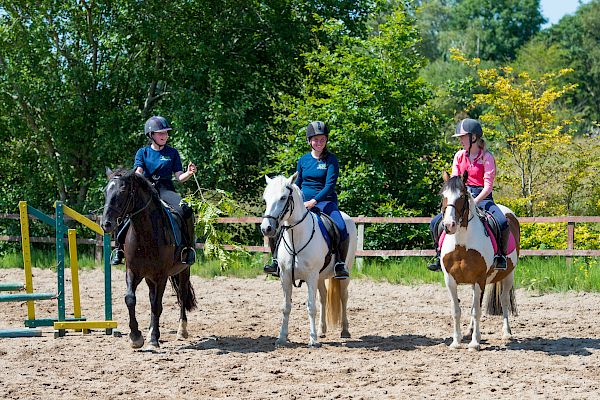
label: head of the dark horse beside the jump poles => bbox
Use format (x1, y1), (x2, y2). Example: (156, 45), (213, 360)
(100, 168), (135, 233)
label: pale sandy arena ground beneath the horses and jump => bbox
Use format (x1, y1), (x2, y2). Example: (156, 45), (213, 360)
(0, 269), (600, 400)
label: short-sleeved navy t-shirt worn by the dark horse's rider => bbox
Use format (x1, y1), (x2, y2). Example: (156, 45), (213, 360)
(133, 146), (183, 182)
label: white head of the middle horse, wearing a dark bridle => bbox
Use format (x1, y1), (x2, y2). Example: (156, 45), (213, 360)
(260, 172), (298, 237)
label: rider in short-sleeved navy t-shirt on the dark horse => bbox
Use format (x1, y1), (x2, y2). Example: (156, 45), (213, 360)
(112, 116), (196, 265)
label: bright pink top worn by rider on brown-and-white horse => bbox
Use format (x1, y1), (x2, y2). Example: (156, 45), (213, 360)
(452, 150), (496, 189)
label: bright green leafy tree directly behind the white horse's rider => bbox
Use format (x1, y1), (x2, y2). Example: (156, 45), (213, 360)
(267, 4), (442, 245)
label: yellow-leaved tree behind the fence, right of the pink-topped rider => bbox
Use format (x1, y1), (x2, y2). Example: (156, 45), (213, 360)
(454, 53), (575, 215)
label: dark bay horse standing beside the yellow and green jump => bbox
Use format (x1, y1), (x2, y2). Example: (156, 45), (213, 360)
(101, 170), (196, 350)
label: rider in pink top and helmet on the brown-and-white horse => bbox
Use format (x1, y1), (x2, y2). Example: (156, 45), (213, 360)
(428, 118), (509, 271)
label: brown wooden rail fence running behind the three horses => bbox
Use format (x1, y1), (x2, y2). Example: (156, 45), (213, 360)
(0, 214), (600, 257)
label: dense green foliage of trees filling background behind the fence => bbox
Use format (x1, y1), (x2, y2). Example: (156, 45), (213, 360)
(0, 0), (600, 256)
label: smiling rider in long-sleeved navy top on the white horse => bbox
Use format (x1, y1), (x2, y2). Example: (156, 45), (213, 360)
(264, 121), (349, 279)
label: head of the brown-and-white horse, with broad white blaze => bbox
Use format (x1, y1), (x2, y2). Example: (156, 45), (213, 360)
(441, 171), (471, 235)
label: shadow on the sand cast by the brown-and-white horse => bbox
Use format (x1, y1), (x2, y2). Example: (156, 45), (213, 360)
(486, 336), (600, 357)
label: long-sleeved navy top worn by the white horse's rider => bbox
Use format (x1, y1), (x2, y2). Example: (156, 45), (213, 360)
(296, 153), (340, 204)
